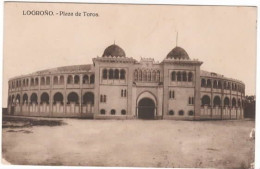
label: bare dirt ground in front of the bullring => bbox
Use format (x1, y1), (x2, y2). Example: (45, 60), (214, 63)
(2, 118), (255, 168)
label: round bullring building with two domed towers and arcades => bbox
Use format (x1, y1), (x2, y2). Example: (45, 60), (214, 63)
(8, 44), (245, 120)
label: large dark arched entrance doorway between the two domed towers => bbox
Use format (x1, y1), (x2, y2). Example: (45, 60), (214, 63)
(138, 98), (155, 119)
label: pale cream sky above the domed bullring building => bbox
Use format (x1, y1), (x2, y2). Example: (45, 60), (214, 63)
(2, 2), (257, 107)
